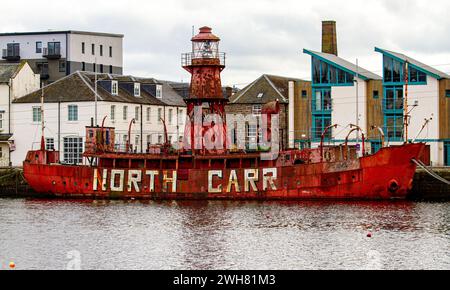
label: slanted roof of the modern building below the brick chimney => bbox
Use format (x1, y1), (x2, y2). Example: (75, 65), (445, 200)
(303, 49), (382, 80)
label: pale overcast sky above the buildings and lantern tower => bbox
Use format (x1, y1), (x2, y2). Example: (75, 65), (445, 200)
(0, 0), (450, 87)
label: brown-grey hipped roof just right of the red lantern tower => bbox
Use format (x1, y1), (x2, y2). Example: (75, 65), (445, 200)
(230, 74), (309, 104)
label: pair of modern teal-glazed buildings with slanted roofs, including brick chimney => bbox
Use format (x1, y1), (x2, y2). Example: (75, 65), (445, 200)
(303, 21), (450, 166)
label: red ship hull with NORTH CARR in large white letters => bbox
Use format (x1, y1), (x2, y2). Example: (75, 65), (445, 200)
(24, 143), (425, 200)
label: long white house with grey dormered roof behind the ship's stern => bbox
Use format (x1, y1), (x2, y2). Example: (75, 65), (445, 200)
(12, 72), (186, 165)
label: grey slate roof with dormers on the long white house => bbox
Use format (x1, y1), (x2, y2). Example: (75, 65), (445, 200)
(14, 71), (186, 107)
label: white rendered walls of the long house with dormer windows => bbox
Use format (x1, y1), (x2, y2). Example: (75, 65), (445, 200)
(11, 102), (186, 166)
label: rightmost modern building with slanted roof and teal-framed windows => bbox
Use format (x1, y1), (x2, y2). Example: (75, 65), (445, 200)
(374, 47), (450, 166)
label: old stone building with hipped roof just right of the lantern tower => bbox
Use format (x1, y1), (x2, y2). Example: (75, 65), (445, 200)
(227, 74), (311, 149)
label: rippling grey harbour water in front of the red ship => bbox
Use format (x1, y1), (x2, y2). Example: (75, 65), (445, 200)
(0, 199), (450, 269)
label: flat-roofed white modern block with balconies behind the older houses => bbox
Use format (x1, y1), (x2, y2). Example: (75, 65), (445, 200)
(0, 30), (124, 84)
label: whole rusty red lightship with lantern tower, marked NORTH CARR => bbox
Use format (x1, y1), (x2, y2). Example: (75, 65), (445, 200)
(23, 27), (425, 200)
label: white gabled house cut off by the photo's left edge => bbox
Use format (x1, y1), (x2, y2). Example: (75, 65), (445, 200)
(0, 61), (40, 167)
